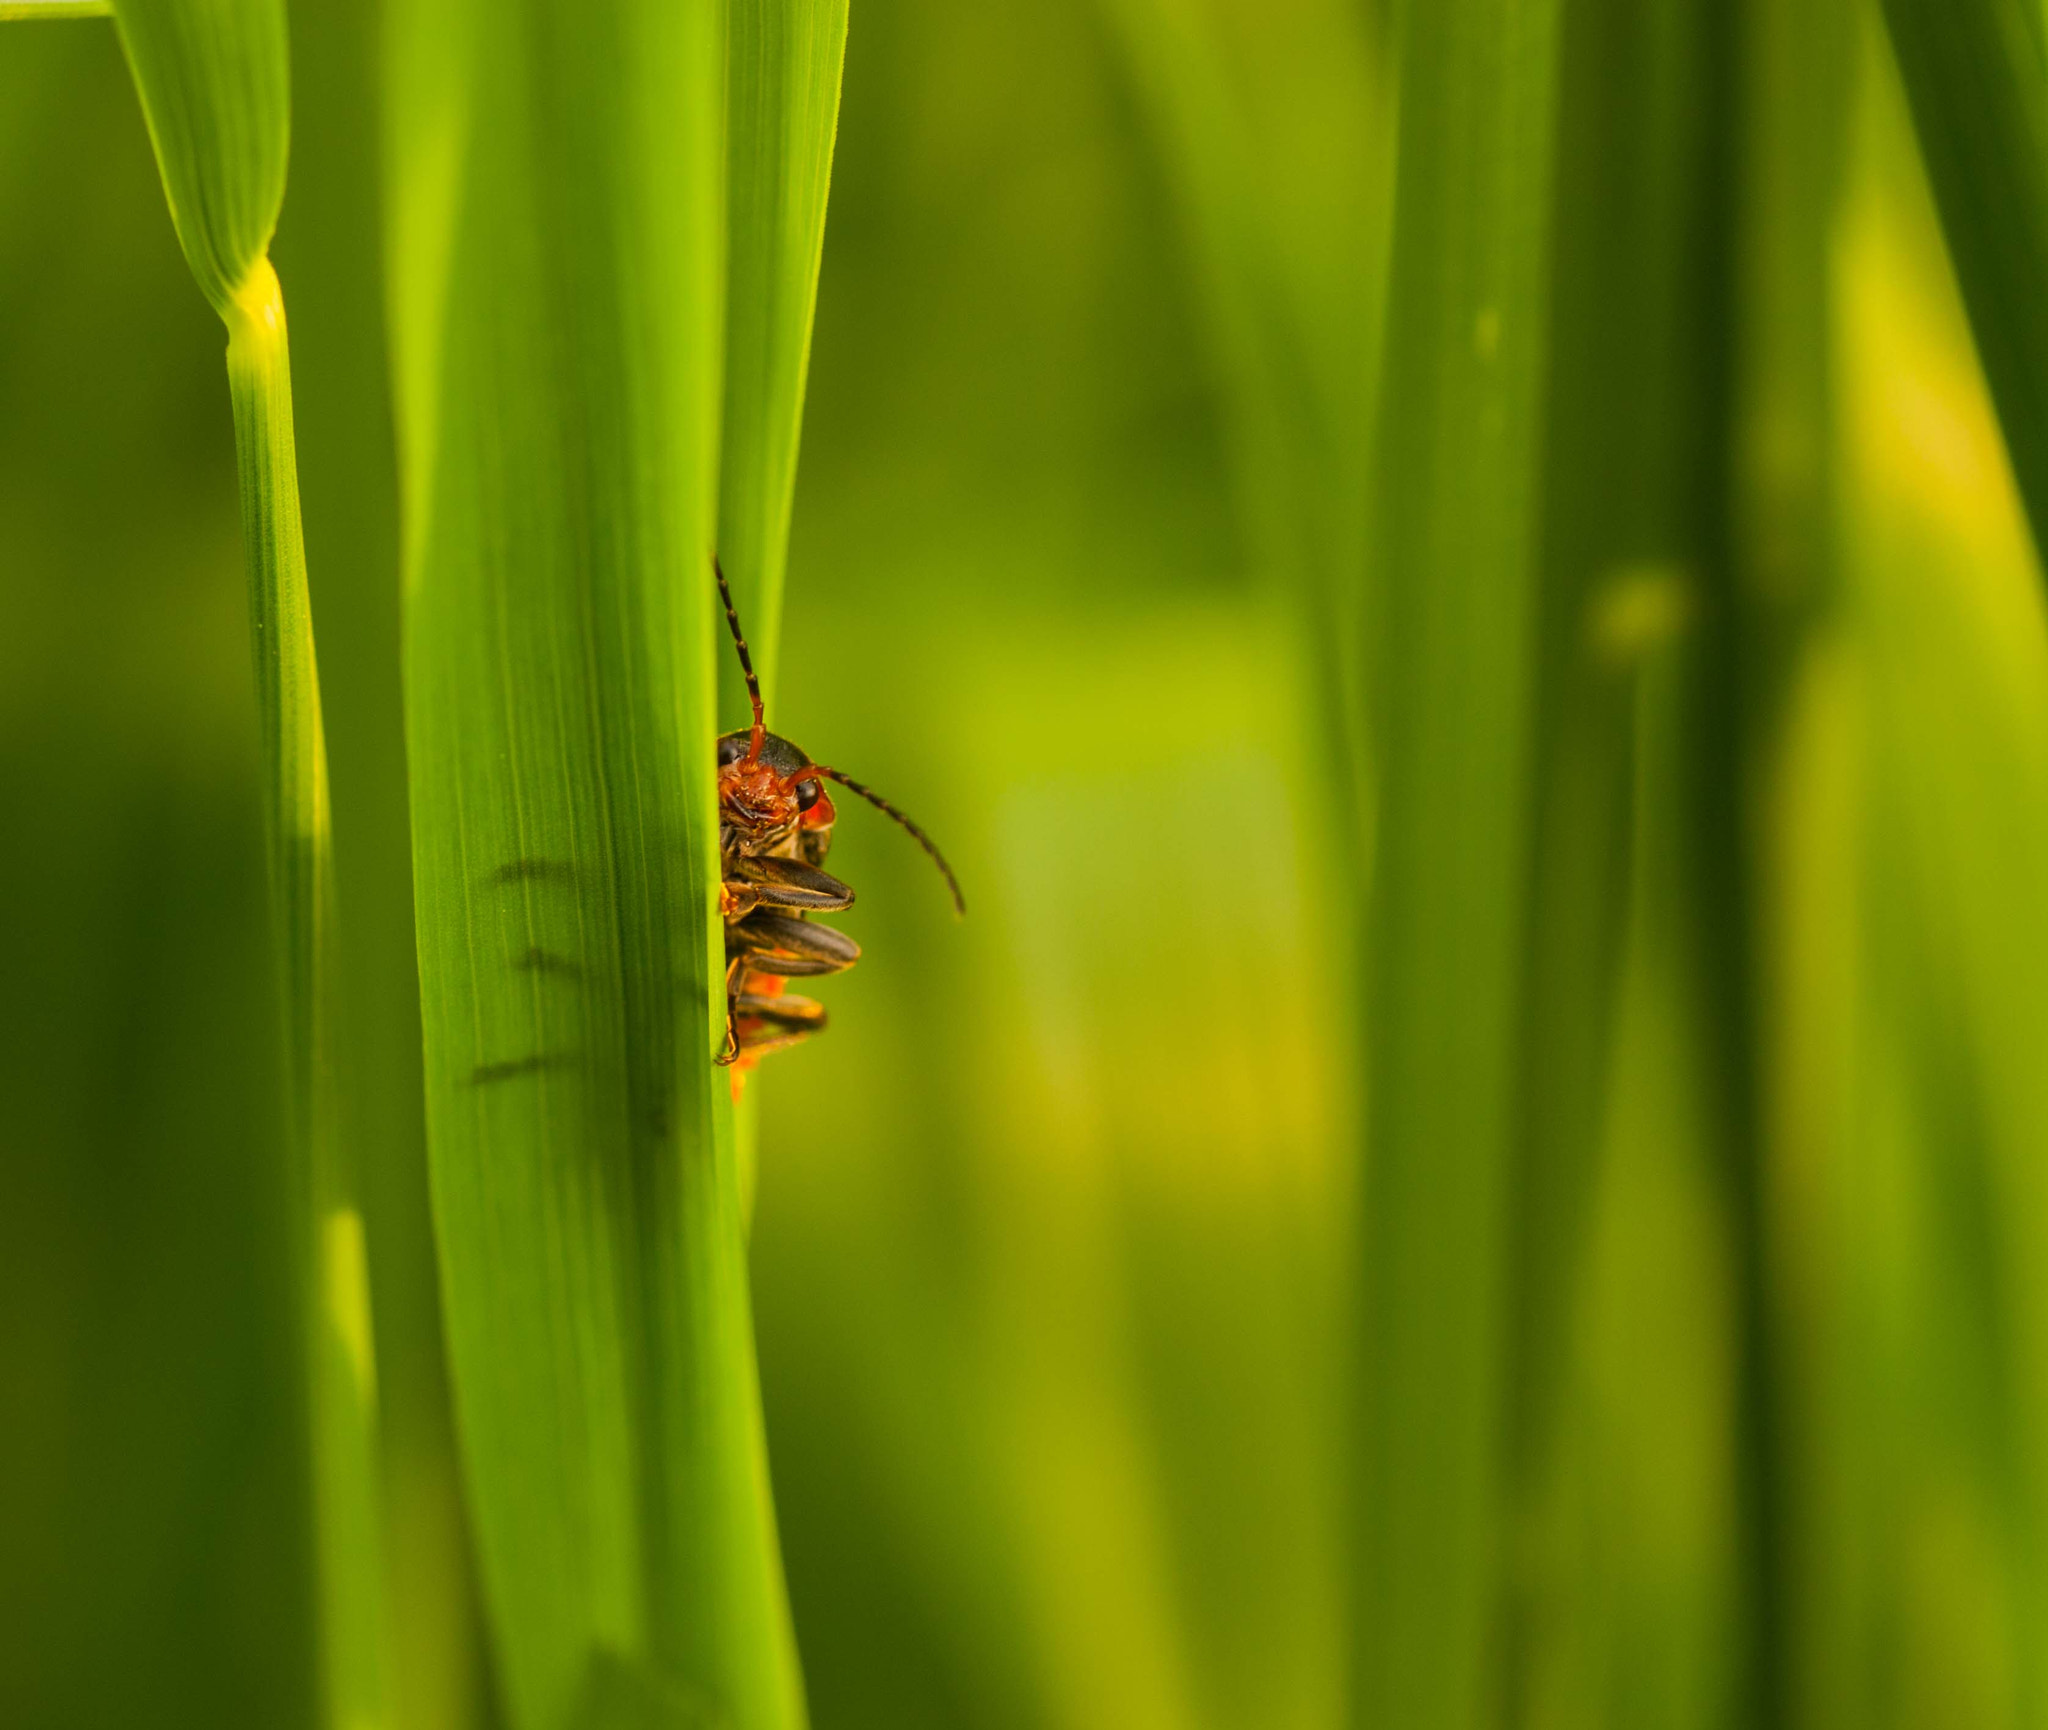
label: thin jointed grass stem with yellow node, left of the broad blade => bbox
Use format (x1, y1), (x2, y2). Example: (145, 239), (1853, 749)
(115, 0), (385, 1726)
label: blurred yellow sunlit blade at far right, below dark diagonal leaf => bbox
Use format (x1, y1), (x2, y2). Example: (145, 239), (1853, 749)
(1829, 50), (2048, 1703)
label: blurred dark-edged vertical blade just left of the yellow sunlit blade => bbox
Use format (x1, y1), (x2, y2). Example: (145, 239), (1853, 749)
(1728, 0), (1858, 1726)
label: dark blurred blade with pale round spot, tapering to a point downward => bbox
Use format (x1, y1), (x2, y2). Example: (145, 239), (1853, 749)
(1513, 0), (1716, 1476)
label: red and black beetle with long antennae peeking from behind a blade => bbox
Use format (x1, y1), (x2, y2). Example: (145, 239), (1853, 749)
(711, 559), (967, 1093)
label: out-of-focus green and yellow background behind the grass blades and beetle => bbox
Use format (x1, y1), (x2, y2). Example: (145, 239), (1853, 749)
(0, 0), (2048, 1730)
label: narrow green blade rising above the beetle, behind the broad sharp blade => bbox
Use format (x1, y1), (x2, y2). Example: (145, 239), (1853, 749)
(719, 0), (846, 708)
